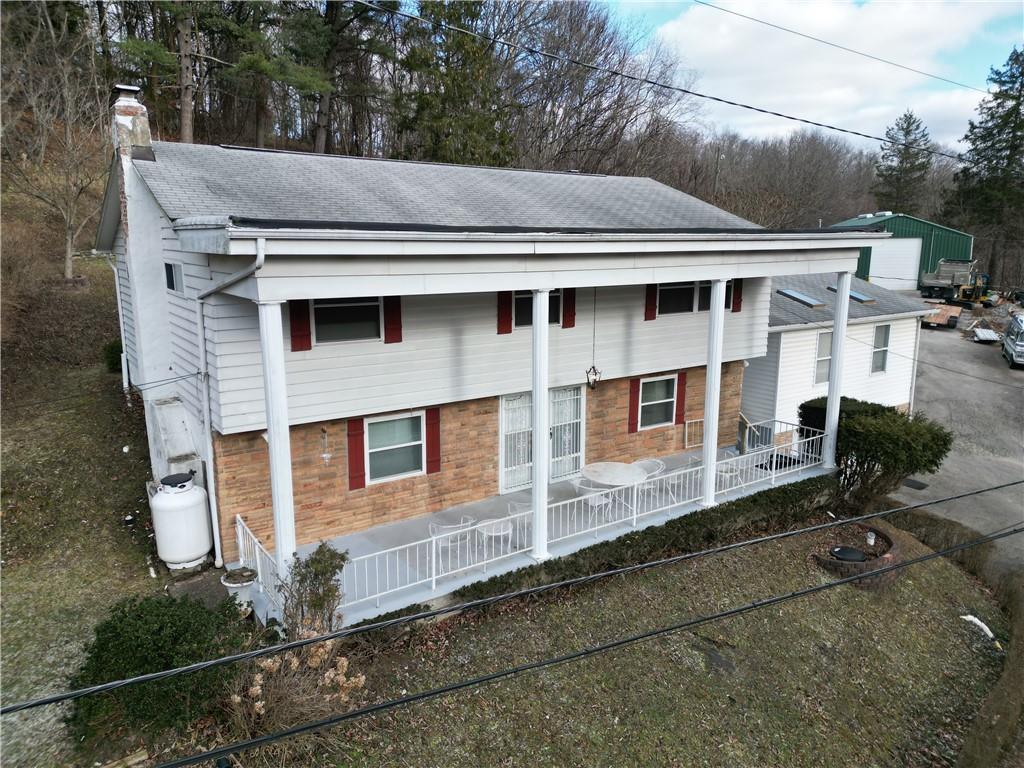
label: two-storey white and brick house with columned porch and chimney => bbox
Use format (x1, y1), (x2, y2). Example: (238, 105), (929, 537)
(98, 86), (888, 621)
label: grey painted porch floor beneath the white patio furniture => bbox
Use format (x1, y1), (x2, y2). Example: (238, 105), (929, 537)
(274, 450), (827, 625)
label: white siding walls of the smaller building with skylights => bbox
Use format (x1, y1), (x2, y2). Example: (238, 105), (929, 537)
(770, 317), (918, 422)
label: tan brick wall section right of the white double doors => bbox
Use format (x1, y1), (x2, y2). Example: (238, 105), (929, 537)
(586, 361), (743, 462)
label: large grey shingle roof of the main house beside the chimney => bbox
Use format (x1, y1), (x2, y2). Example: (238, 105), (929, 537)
(134, 141), (761, 231)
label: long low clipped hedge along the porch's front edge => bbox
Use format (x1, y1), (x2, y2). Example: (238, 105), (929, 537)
(456, 477), (835, 600)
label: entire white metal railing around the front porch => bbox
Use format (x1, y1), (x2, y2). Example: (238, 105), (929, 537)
(236, 430), (824, 607)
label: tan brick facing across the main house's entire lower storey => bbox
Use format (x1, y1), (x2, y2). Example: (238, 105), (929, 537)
(213, 362), (743, 562)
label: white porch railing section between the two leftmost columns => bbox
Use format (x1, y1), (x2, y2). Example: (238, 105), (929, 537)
(342, 510), (534, 606)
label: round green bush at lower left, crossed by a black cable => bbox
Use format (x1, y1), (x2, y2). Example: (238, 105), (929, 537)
(69, 595), (247, 738)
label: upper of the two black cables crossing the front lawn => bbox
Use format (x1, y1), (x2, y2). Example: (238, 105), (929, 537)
(0, 480), (1024, 715)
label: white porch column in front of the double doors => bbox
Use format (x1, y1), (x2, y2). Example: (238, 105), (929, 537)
(532, 290), (551, 560)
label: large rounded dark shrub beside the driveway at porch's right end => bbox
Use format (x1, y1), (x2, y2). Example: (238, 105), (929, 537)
(836, 411), (953, 504)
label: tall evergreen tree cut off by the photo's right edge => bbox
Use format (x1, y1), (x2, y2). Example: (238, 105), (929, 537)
(950, 48), (1024, 287)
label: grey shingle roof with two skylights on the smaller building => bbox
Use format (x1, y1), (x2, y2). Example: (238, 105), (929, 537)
(768, 273), (933, 330)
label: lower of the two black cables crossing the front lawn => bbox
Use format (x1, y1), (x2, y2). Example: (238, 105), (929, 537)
(158, 526), (1024, 768)
